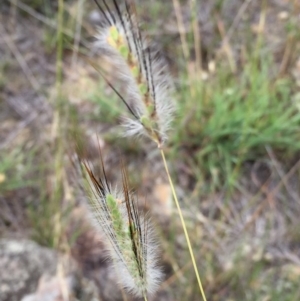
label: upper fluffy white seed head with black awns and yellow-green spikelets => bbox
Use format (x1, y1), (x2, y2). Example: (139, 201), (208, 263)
(95, 0), (174, 146)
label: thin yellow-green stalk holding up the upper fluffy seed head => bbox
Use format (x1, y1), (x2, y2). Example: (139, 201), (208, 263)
(160, 148), (207, 301)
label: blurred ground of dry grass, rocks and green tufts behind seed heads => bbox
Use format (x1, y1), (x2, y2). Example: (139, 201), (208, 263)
(0, 0), (300, 301)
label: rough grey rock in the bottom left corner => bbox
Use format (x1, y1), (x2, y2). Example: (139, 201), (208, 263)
(0, 239), (99, 301)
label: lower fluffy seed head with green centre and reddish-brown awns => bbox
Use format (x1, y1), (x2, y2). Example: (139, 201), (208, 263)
(81, 159), (162, 296)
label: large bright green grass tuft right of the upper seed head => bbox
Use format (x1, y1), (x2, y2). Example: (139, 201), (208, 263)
(172, 51), (300, 188)
